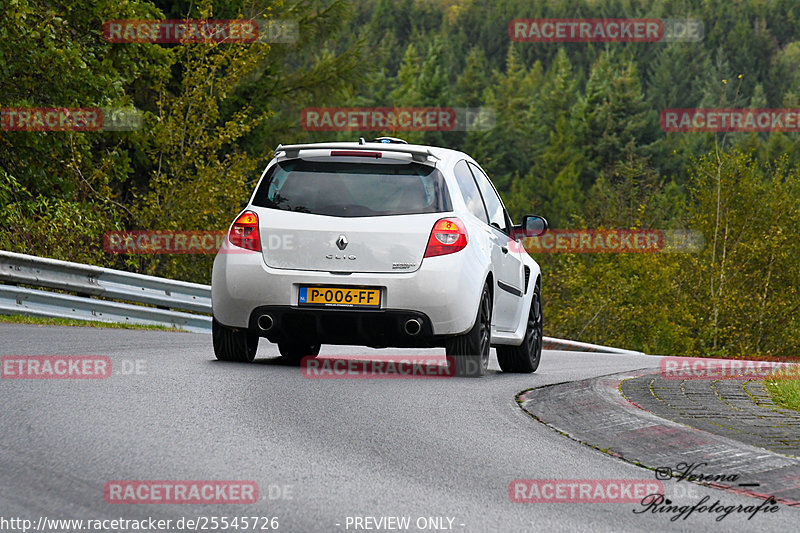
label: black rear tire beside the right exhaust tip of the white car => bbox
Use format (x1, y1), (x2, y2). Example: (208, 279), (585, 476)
(445, 284), (492, 378)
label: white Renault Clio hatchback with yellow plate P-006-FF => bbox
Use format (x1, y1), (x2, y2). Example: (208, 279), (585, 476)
(211, 137), (547, 376)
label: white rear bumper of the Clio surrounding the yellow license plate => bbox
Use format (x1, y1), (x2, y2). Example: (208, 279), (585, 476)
(211, 242), (487, 334)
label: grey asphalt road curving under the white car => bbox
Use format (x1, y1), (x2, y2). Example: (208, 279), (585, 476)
(0, 325), (800, 532)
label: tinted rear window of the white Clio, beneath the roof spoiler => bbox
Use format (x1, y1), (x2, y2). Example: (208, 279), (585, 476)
(253, 159), (452, 217)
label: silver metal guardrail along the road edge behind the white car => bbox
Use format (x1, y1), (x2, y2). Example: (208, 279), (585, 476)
(0, 251), (643, 355)
